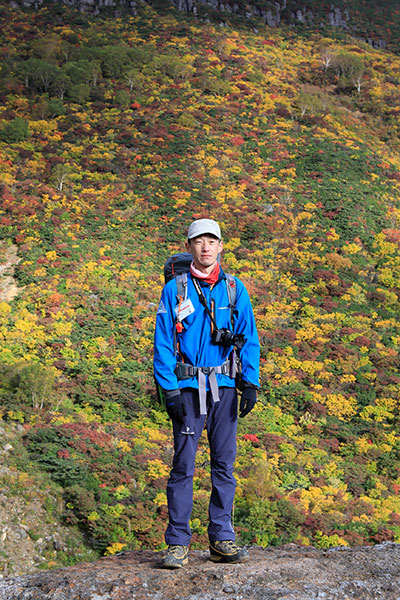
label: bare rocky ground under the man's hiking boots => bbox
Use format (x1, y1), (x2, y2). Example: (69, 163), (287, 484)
(0, 542), (400, 600)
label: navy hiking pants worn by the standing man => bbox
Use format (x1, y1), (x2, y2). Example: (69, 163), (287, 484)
(165, 387), (237, 546)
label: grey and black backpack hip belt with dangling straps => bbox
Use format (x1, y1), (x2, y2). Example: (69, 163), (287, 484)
(175, 358), (236, 415)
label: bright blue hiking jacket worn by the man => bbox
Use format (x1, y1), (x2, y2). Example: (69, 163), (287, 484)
(154, 269), (260, 390)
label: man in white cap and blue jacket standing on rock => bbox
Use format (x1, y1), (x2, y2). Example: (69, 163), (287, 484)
(154, 219), (260, 568)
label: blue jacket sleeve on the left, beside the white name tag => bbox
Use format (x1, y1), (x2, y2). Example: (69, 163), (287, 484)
(153, 280), (179, 390)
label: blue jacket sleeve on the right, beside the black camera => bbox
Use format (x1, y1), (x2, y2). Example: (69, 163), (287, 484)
(235, 279), (260, 387)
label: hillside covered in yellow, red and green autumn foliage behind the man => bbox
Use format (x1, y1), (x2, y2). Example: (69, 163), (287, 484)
(0, 1), (400, 565)
